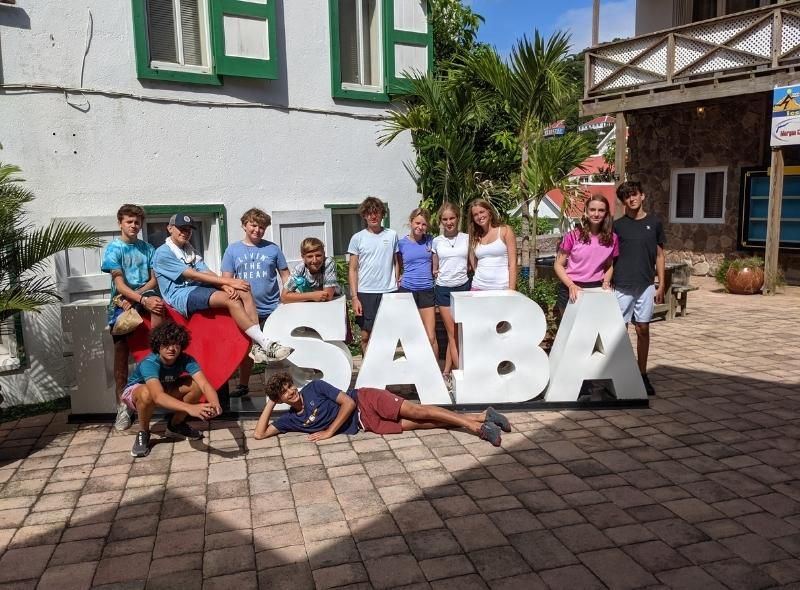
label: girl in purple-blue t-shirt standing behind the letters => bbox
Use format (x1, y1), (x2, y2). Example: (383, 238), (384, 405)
(397, 207), (439, 358)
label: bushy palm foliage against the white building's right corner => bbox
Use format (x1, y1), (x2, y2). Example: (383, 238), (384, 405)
(378, 74), (491, 223)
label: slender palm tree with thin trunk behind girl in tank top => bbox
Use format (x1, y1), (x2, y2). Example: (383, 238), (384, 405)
(466, 31), (588, 286)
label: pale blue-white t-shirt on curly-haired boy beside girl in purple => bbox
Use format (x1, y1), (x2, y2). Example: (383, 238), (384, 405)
(347, 228), (397, 293)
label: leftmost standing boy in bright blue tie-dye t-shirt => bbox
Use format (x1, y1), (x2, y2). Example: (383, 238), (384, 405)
(100, 205), (164, 431)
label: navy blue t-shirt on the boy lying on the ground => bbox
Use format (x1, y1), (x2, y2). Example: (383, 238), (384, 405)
(272, 381), (358, 434)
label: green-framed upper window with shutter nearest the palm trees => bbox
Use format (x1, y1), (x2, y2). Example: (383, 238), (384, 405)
(329, 0), (433, 101)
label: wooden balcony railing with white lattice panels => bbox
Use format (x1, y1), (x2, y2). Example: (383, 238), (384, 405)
(583, 0), (800, 114)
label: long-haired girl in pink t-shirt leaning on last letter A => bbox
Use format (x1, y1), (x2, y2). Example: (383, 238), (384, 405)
(555, 195), (619, 312)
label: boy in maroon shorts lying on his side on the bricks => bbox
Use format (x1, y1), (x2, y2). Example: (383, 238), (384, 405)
(255, 372), (511, 447)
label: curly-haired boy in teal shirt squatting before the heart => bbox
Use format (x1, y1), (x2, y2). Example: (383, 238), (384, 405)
(121, 322), (222, 457)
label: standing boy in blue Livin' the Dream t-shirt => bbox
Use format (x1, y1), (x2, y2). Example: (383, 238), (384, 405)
(222, 208), (289, 397)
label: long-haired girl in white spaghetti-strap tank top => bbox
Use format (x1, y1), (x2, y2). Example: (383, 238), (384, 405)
(469, 199), (517, 291)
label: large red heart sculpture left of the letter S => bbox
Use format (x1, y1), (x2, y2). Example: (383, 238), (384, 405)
(128, 305), (250, 389)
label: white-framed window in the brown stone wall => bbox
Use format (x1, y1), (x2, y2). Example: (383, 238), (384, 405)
(670, 167), (727, 223)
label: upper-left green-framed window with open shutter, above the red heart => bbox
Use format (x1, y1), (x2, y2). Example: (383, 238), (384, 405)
(132, 0), (277, 85)
